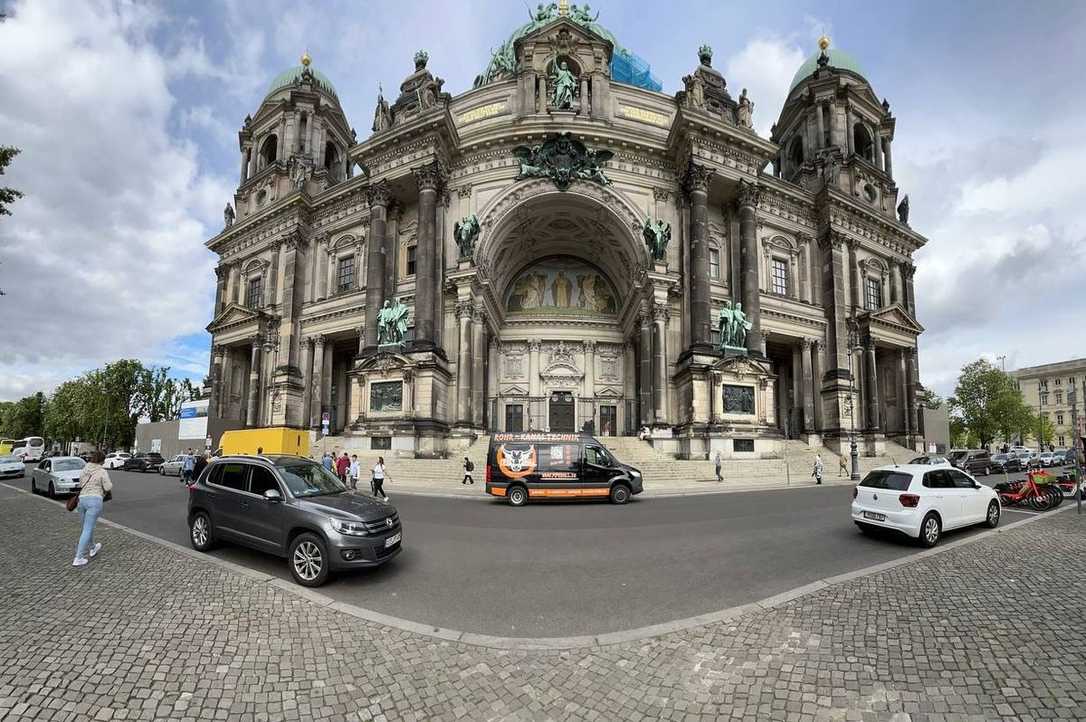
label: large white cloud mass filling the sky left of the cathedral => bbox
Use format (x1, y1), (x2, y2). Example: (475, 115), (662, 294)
(0, 0), (232, 398)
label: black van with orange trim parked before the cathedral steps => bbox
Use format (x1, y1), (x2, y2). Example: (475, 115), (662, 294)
(487, 431), (642, 506)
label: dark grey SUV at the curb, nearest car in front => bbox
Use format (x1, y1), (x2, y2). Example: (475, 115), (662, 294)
(189, 456), (403, 586)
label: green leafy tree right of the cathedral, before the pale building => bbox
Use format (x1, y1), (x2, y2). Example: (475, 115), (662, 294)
(947, 358), (1036, 446)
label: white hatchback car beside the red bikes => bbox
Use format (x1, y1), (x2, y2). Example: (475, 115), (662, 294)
(853, 465), (1001, 546)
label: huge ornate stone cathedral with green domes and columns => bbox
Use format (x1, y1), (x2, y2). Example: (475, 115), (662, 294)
(201, 1), (925, 459)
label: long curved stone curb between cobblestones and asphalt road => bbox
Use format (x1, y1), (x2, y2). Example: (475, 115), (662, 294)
(0, 482), (1074, 651)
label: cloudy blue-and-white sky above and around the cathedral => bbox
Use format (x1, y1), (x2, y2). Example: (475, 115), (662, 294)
(0, 0), (1086, 400)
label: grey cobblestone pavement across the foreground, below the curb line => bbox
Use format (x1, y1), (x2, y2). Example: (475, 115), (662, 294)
(0, 489), (1086, 722)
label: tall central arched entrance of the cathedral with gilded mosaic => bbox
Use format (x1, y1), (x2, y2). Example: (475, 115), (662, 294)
(477, 181), (647, 435)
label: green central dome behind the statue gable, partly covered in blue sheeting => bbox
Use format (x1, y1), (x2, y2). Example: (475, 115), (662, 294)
(475, 3), (664, 92)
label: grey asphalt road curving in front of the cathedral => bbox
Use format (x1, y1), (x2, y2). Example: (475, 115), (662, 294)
(8, 462), (1038, 636)
